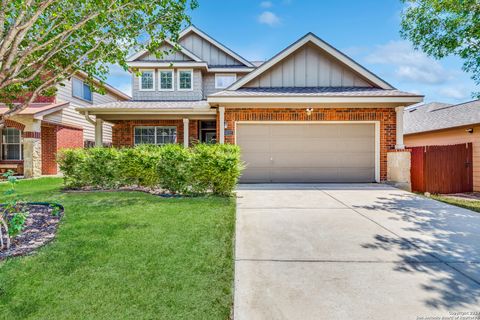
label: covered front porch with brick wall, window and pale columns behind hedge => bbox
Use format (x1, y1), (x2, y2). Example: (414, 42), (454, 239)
(78, 101), (225, 147)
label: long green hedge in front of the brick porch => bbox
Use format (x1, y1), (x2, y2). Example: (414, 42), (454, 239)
(57, 144), (242, 196)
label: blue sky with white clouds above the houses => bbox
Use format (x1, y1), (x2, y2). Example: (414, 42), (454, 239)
(108, 0), (479, 103)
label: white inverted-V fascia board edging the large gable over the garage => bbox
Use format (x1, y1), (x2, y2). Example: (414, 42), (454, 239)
(228, 33), (394, 90)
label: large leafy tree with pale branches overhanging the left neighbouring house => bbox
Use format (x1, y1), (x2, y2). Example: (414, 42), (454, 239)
(0, 0), (197, 127)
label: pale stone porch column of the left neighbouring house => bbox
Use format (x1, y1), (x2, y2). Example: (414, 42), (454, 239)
(22, 120), (42, 178)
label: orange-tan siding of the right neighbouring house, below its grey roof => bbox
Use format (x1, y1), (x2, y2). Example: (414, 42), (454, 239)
(404, 126), (480, 191)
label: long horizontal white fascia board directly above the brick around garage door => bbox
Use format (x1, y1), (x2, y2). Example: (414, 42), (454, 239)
(207, 96), (423, 104)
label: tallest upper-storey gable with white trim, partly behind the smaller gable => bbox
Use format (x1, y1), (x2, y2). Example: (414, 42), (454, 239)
(178, 25), (254, 68)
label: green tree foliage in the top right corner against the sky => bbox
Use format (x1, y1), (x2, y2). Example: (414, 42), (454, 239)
(401, 0), (480, 97)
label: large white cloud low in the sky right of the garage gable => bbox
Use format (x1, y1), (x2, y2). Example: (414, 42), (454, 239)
(365, 41), (453, 84)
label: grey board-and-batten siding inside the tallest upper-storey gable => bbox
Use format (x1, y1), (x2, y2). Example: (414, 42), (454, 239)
(180, 32), (243, 66)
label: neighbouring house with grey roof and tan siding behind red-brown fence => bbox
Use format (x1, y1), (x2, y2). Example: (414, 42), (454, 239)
(404, 100), (480, 191)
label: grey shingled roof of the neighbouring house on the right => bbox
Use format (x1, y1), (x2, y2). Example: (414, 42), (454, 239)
(403, 100), (480, 134)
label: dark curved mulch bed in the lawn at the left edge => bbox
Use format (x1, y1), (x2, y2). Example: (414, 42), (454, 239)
(0, 203), (63, 260)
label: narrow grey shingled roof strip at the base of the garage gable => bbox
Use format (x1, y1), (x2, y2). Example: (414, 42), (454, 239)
(210, 87), (423, 97)
